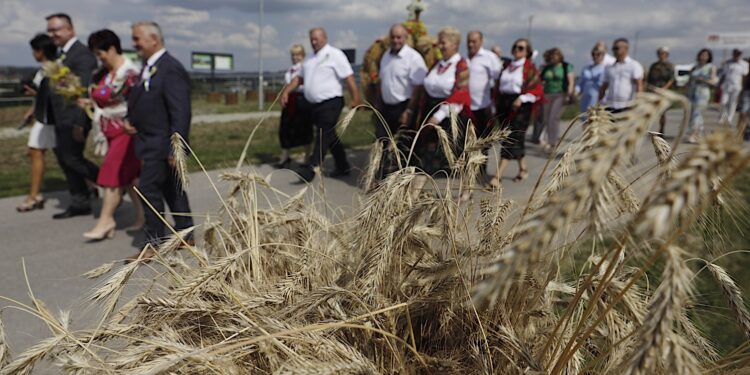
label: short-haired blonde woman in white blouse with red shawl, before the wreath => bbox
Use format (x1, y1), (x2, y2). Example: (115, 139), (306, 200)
(412, 27), (471, 174)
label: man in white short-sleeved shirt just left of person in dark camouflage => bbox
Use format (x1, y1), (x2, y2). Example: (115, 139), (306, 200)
(599, 38), (643, 113)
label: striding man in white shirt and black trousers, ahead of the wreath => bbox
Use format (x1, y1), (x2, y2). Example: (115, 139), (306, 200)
(281, 27), (360, 182)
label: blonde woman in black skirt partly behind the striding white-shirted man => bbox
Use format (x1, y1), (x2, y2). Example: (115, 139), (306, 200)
(275, 44), (313, 168)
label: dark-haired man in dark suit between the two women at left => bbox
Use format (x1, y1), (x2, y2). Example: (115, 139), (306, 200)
(46, 13), (99, 219)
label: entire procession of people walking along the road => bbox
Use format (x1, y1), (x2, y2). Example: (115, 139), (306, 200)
(18, 13), (750, 257)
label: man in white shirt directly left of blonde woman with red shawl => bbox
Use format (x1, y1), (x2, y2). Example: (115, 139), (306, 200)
(375, 24), (427, 178)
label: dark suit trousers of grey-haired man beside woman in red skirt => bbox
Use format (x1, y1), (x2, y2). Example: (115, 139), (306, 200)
(138, 160), (193, 245)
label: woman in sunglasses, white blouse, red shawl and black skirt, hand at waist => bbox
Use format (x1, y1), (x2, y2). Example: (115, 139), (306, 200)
(490, 39), (544, 188)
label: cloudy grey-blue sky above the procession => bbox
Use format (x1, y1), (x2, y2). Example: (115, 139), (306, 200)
(0, 0), (750, 71)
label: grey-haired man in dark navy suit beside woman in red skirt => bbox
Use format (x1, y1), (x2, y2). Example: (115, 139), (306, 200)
(126, 22), (193, 258)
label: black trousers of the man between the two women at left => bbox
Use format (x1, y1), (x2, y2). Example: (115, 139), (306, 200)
(55, 126), (99, 209)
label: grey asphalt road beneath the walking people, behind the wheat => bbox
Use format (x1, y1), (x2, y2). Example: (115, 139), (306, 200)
(0, 111), (728, 374)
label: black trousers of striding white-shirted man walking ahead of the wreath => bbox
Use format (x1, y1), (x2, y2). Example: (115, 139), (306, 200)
(310, 96), (349, 170)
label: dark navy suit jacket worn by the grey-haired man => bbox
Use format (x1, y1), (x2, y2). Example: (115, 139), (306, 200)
(128, 52), (191, 160)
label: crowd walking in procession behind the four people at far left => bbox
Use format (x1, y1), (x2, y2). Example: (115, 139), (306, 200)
(278, 24), (750, 197)
